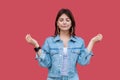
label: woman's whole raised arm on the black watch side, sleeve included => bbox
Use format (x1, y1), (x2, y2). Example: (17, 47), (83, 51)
(25, 34), (51, 68)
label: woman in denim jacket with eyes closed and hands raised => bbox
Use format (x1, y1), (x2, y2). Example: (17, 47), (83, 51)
(26, 9), (102, 80)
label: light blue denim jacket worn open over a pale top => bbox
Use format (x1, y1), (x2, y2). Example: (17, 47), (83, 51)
(36, 35), (93, 80)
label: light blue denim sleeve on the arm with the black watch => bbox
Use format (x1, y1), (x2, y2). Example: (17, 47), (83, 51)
(36, 39), (51, 68)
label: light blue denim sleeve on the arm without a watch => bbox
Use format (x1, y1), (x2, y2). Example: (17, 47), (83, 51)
(78, 41), (93, 66)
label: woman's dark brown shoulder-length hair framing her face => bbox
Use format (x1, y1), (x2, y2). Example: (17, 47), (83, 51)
(54, 9), (75, 36)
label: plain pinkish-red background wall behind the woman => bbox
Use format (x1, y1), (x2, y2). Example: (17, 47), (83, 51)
(0, 0), (120, 80)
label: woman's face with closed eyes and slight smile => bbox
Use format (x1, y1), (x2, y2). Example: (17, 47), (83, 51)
(57, 14), (71, 31)
